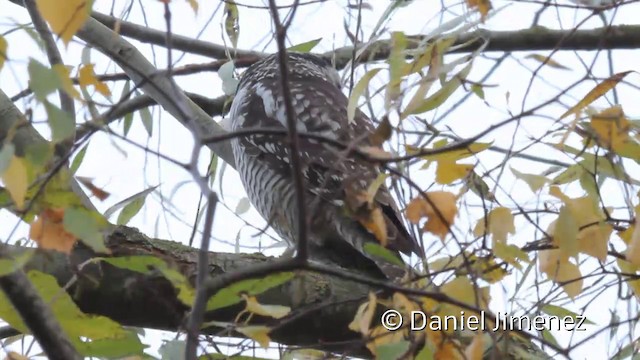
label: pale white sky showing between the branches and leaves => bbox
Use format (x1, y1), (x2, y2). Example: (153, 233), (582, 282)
(0, 0), (640, 359)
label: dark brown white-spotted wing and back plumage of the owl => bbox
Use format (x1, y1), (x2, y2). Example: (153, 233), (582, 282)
(238, 79), (421, 264)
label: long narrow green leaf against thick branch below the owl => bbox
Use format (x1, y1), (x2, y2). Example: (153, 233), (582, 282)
(207, 272), (294, 311)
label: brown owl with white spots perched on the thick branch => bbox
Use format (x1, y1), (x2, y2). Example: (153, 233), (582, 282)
(229, 52), (420, 279)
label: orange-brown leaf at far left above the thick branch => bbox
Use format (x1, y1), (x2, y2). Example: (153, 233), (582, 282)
(29, 209), (76, 254)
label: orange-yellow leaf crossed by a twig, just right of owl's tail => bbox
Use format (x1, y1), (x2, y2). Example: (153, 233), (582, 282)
(406, 191), (458, 241)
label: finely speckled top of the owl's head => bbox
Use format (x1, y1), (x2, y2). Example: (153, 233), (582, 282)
(239, 52), (342, 89)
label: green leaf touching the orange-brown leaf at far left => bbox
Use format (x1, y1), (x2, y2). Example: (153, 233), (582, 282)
(62, 207), (109, 253)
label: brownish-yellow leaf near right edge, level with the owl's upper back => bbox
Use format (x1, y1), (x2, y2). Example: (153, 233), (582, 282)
(591, 105), (631, 151)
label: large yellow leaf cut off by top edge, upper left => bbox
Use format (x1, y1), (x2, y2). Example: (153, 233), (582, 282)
(36, 0), (93, 44)
